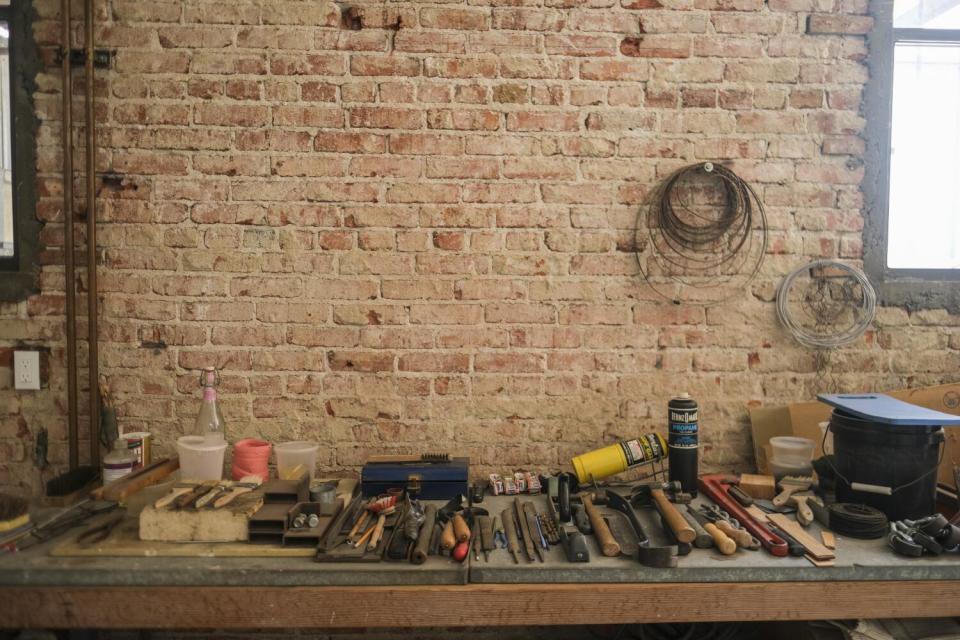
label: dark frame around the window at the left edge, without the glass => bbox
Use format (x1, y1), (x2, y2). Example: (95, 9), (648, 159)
(0, 0), (43, 301)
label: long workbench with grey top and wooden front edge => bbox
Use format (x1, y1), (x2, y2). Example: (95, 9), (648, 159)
(0, 498), (960, 629)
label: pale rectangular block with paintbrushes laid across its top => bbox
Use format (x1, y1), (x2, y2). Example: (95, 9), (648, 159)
(140, 491), (263, 542)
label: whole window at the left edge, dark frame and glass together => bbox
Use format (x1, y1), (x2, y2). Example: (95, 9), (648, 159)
(0, 0), (40, 300)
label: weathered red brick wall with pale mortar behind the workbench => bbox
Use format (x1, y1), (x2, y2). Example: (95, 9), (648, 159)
(0, 0), (960, 488)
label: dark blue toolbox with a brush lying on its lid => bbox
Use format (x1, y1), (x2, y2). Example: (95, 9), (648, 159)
(360, 455), (470, 500)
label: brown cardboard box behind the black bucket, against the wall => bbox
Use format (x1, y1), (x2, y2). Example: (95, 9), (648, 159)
(750, 383), (960, 487)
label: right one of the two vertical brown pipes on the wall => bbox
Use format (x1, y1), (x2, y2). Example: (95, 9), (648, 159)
(83, 0), (100, 469)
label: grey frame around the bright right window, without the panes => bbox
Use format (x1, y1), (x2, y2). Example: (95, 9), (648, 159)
(863, 1), (960, 312)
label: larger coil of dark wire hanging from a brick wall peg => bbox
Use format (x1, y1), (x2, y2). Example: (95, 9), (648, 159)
(636, 162), (767, 305)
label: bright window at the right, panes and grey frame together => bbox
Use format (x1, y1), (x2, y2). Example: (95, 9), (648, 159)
(865, 0), (960, 306)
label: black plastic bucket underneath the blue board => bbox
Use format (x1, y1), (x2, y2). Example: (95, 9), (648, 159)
(830, 409), (944, 520)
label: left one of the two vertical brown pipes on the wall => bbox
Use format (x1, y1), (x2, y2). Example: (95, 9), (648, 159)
(60, 0), (80, 469)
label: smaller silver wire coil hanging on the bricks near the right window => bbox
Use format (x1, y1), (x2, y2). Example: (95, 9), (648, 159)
(777, 260), (877, 392)
